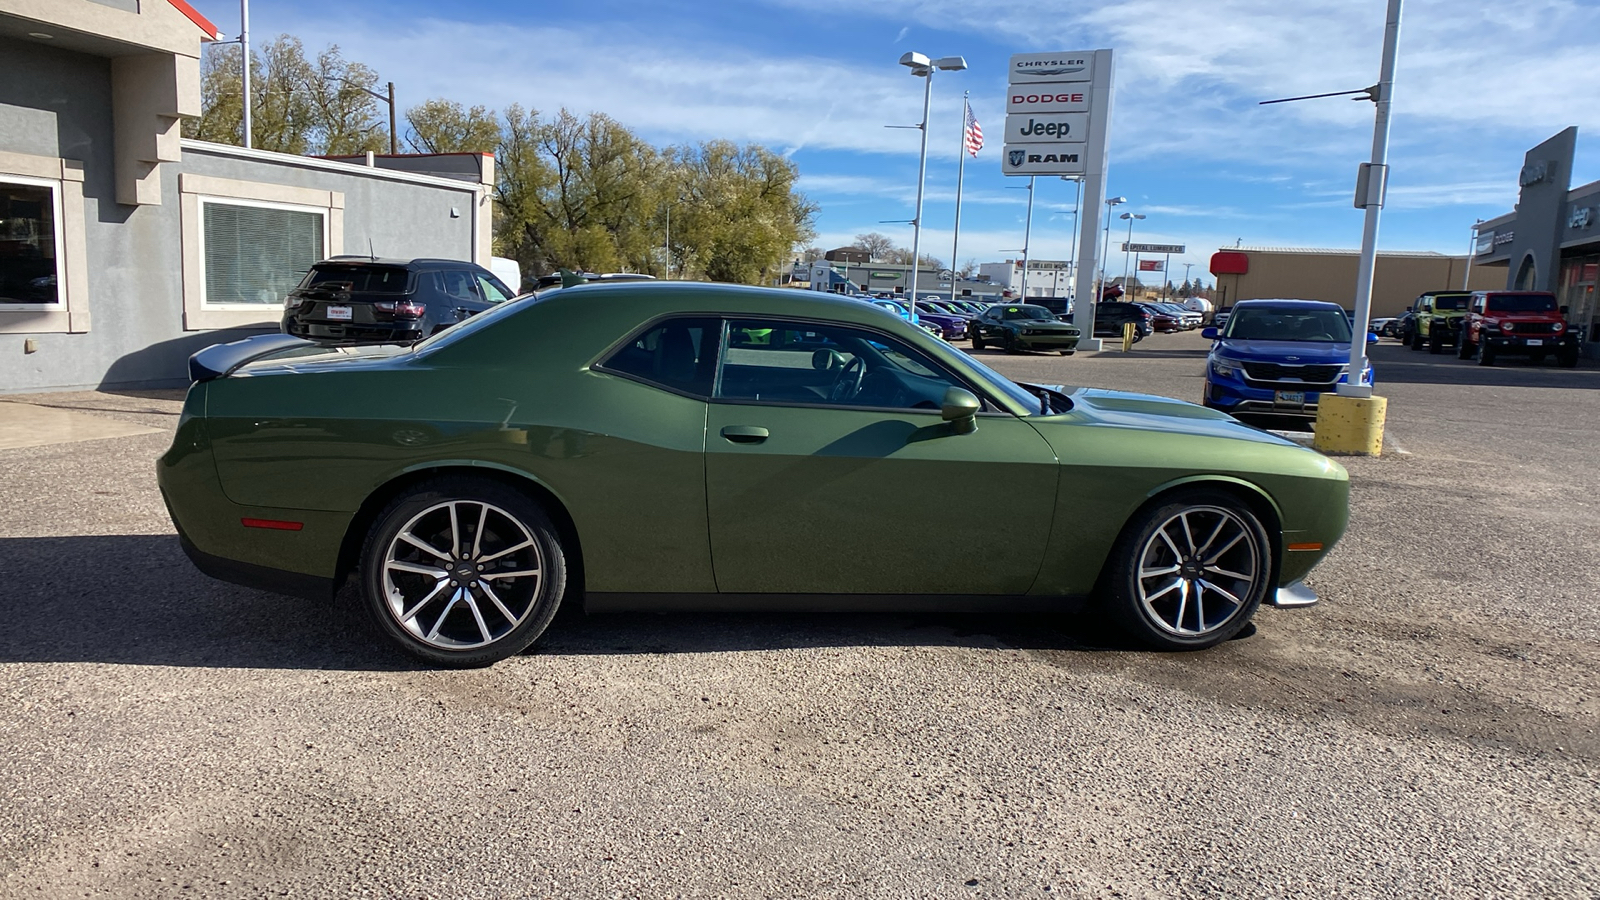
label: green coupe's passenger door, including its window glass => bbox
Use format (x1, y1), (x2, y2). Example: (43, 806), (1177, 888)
(706, 319), (1059, 594)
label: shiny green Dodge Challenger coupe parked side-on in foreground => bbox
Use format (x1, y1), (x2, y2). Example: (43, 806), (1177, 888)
(158, 282), (1349, 666)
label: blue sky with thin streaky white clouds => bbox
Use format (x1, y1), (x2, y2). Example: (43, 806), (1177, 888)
(195, 0), (1600, 280)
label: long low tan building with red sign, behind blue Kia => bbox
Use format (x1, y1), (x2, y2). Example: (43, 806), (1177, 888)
(1211, 247), (1506, 319)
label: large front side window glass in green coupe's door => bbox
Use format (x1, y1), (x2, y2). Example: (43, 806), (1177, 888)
(717, 319), (966, 412)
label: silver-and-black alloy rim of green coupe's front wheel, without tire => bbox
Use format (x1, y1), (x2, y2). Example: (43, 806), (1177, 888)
(1134, 506), (1267, 637)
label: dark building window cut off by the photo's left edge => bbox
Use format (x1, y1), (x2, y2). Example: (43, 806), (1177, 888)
(0, 176), (62, 309)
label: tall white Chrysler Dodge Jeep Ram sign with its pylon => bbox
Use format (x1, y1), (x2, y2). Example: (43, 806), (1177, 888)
(1000, 50), (1112, 351)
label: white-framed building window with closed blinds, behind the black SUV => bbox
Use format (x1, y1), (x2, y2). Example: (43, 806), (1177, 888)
(200, 199), (328, 309)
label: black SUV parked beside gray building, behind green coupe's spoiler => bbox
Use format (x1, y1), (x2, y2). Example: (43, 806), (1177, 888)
(283, 256), (512, 344)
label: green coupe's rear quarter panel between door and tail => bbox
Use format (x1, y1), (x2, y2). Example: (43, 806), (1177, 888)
(206, 294), (715, 591)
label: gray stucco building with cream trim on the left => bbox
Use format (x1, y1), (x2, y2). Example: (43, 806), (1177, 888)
(0, 0), (494, 392)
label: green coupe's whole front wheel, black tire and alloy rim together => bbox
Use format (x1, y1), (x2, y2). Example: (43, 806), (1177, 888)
(1109, 490), (1272, 650)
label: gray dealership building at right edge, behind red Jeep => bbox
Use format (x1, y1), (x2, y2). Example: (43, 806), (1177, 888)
(1477, 127), (1600, 357)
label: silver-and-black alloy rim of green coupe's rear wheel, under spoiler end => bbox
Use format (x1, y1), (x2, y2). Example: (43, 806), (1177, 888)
(381, 500), (544, 650)
